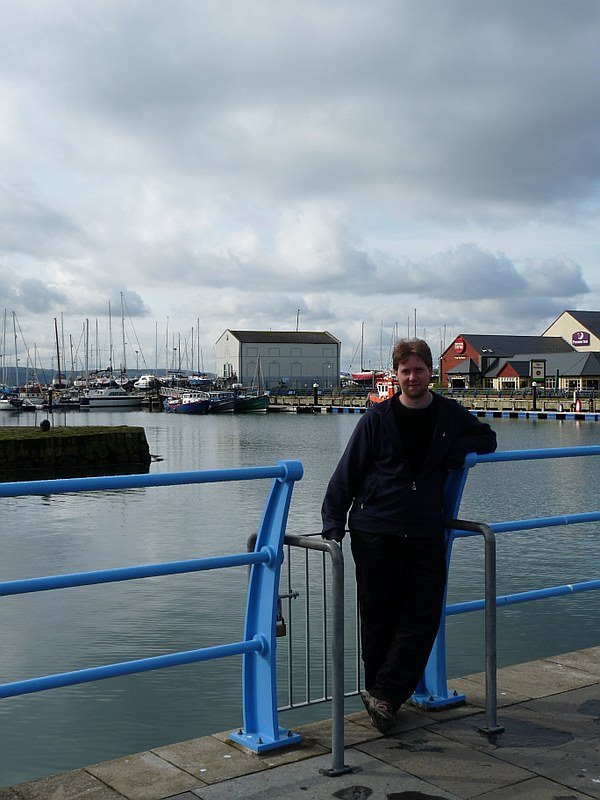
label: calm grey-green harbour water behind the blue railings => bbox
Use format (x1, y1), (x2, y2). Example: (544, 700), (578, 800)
(0, 411), (600, 786)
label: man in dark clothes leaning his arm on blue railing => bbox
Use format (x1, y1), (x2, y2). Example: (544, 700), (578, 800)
(322, 339), (496, 733)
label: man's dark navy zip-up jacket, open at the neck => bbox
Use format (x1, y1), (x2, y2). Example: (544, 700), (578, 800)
(321, 395), (496, 541)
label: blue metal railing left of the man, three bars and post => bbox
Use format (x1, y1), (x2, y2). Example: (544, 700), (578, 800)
(0, 461), (303, 752)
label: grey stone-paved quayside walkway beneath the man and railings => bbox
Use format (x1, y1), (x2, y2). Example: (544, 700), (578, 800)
(0, 647), (600, 800)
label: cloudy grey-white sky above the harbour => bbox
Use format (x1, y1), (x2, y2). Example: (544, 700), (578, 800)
(0, 0), (600, 372)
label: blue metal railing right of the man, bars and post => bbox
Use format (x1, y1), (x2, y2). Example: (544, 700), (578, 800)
(411, 446), (600, 712)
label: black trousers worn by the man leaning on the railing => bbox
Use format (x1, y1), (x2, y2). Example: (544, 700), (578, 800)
(351, 530), (446, 710)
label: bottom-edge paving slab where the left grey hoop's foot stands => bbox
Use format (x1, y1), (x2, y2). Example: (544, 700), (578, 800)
(193, 749), (460, 800)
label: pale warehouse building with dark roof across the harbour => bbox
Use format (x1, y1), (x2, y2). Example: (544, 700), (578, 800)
(215, 329), (341, 391)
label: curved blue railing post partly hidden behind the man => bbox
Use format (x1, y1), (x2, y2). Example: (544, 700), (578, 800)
(409, 454), (474, 710)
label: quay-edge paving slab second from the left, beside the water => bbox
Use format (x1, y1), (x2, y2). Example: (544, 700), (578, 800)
(86, 752), (200, 800)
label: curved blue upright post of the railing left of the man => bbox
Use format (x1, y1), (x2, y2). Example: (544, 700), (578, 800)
(230, 461), (303, 753)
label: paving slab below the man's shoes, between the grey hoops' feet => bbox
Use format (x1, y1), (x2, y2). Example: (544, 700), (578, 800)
(357, 729), (534, 798)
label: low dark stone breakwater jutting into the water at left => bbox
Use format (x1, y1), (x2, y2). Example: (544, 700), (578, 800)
(0, 425), (151, 480)
